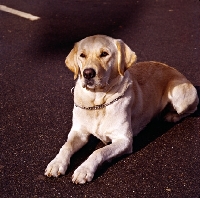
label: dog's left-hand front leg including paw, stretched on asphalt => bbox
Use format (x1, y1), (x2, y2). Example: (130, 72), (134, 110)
(45, 131), (89, 177)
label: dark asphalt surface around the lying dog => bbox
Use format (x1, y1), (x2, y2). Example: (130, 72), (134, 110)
(0, 0), (200, 198)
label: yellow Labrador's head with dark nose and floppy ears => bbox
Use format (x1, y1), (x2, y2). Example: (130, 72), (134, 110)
(65, 35), (137, 89)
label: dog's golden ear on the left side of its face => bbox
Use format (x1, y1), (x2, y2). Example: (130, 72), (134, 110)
(65, 44), (79, 80)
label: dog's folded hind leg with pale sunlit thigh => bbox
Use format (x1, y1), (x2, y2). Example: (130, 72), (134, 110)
(165, 83), (199, 122)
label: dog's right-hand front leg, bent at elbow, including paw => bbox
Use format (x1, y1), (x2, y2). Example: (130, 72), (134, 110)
(72, 138), (132, 184)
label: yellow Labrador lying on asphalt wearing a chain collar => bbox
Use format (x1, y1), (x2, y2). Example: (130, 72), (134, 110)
(45, 35), (199, 184)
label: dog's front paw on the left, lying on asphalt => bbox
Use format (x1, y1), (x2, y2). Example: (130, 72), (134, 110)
(44, 158), (69, 177)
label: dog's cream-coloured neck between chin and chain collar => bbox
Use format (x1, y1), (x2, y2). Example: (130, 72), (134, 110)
(74, 72), (132, 108)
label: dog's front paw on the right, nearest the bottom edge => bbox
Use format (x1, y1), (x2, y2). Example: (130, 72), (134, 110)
(72, 165), (94, 184)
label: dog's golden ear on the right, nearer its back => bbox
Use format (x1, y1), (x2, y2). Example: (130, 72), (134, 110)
(116, 39), (137, 75)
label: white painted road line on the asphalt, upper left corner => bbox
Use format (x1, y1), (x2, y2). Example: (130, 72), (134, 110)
(0, 5), (40, 21)
